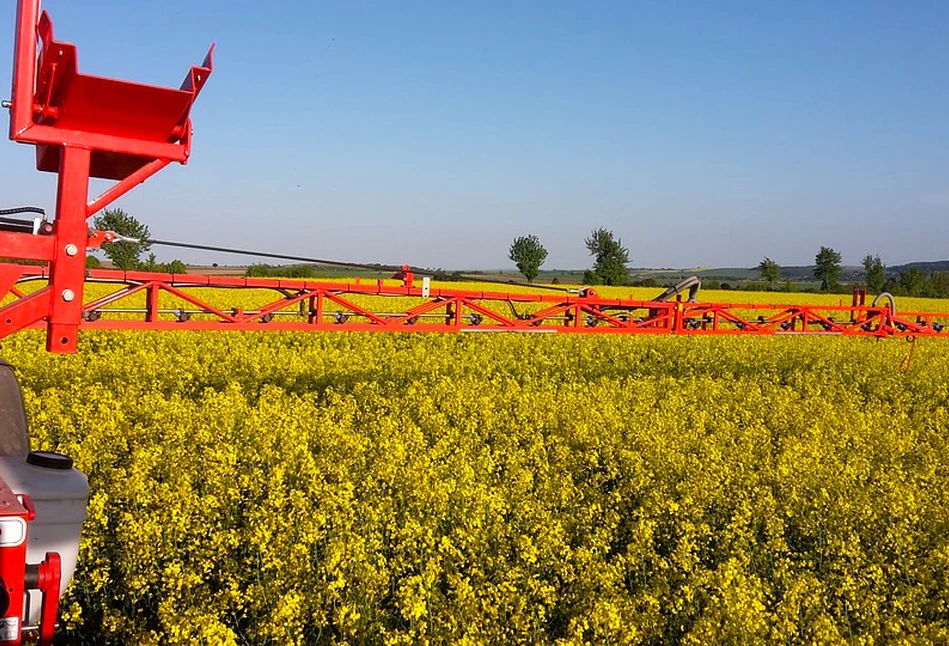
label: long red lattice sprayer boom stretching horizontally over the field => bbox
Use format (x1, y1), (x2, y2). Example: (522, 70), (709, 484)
(0, 265), (949, 338)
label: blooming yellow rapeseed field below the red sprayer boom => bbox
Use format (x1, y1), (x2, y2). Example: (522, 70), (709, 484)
(0, 285), (949, 645)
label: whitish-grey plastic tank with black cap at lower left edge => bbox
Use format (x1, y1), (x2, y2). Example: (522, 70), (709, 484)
(0, 451), (89, 625)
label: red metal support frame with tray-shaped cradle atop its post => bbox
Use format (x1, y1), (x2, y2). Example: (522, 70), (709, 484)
(0, 0), (214, 352)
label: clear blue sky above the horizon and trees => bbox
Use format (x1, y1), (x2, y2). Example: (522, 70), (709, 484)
(0, 0), (949, 268)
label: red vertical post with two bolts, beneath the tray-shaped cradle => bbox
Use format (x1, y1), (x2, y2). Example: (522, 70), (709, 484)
(46, 146), (90, 352)
